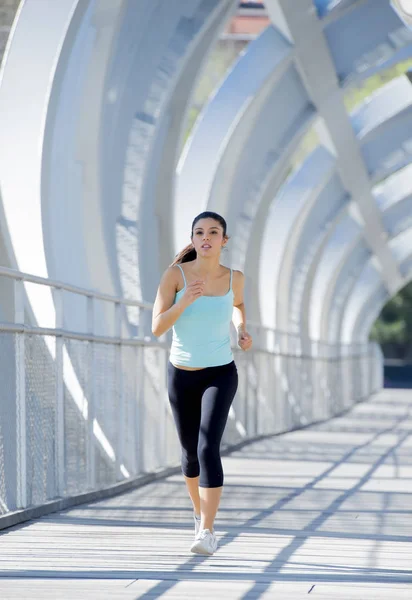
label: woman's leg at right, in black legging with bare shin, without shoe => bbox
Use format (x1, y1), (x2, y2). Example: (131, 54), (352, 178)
(198, 363), (238, 531)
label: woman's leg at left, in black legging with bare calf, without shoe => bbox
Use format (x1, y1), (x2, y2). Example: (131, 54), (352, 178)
(168, 363), (202, 515)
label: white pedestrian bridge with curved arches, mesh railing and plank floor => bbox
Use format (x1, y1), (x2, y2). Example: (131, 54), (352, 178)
(0, 0), (412, 600)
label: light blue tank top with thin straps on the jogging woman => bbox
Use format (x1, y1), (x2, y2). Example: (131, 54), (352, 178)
(170, 265), (233, 367)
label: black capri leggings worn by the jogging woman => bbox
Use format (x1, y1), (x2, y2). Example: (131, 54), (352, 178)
(168, 362), (238, 488)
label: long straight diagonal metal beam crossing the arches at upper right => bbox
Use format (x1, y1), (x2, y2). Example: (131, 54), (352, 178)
(266, 0), (402, 292)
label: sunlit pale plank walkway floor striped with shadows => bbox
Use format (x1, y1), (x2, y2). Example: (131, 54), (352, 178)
(0, 390), (412, 600)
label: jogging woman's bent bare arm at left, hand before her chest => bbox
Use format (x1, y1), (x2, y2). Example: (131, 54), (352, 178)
(152, 267), (204, 337)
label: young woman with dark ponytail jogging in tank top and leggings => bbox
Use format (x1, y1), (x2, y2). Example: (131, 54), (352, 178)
(152, 212), (252, 555)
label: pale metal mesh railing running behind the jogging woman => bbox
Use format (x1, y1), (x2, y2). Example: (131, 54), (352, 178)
(0, 268), (382, 526)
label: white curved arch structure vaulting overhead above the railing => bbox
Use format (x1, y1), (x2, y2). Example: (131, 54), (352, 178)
(0, 0), (412, 376)
